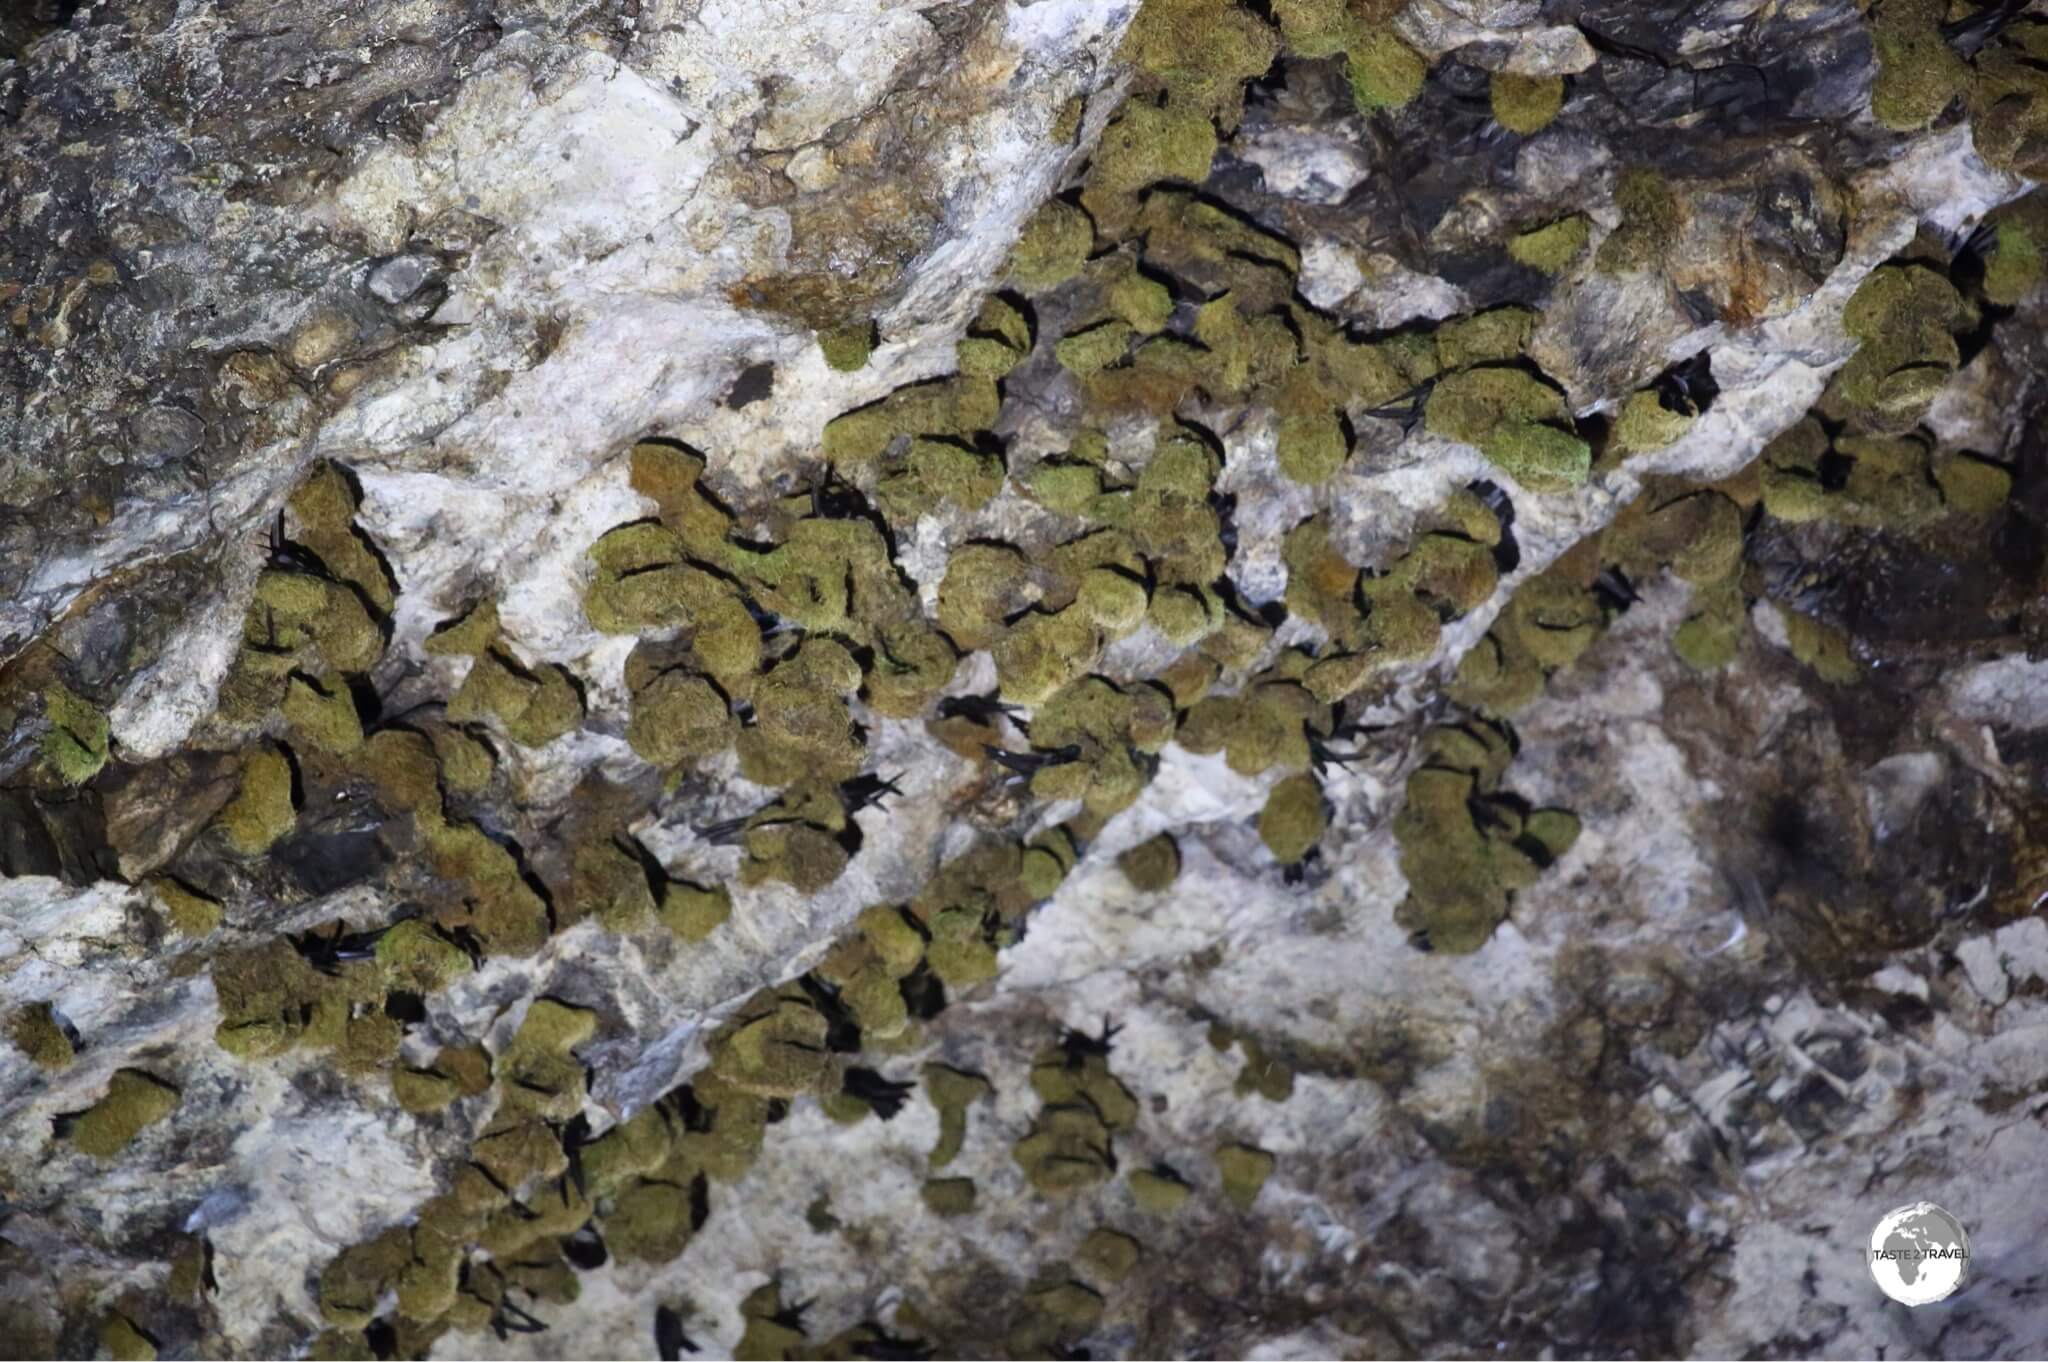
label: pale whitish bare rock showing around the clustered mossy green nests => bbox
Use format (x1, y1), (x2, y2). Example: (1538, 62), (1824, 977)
(12, 0), (2048, 1358)
